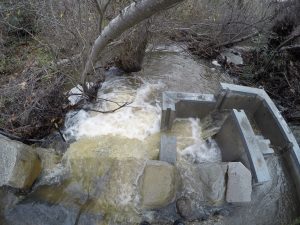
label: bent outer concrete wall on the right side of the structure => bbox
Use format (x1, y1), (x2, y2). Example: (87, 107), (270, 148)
(219, 83), (300, 198)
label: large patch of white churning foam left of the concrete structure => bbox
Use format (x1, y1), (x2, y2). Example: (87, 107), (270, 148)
(64, 83), (162, 140)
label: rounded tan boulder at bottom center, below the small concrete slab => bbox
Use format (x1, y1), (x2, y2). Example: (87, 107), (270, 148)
(140, 160), (176, 209)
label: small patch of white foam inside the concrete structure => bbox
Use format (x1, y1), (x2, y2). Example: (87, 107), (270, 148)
(181, 118), (222, 163)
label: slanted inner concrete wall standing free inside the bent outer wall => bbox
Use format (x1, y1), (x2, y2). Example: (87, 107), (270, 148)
(215, 109), (271, 183)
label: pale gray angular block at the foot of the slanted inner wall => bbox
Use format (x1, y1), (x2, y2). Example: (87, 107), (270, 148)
(226, 162), (252, 203)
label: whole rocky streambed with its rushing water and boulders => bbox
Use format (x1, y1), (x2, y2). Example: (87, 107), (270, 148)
(0, 46), (300, 225)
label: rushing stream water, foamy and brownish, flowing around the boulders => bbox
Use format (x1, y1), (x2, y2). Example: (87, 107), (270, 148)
(0, 44), (297, 225)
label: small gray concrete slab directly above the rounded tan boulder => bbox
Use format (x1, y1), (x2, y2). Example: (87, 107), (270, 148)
(159, 134), (177, 165)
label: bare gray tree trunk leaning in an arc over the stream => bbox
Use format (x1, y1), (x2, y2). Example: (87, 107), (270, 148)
(81, 0), (184, 90)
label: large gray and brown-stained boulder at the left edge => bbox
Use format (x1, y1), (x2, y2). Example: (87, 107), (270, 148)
(0, 137), (41, 189)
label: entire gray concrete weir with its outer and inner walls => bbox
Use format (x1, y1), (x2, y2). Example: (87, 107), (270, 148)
(160, 83), (300, 199)
